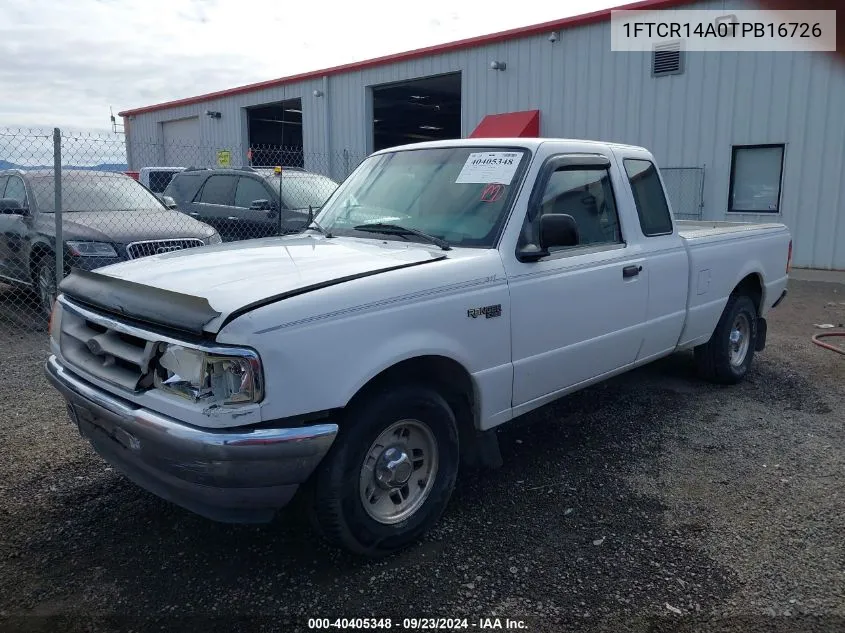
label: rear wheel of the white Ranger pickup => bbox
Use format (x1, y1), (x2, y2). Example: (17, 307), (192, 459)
(694, 295), (757, 384)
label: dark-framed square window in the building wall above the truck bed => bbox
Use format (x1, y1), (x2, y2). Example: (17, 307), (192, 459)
(728, 145), (784, 213)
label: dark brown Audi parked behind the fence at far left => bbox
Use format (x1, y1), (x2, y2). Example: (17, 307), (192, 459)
(0, 170), (221, 314)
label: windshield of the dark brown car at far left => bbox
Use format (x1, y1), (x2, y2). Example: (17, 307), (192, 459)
(32, 173), (164, 213)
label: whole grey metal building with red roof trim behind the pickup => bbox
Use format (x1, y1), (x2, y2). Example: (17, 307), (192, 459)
(121, 0), (845, 269)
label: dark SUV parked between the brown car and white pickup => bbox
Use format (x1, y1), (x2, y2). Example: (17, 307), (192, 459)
(164, 167), (338, 242)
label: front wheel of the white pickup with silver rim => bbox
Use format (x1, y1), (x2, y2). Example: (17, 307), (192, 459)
(308, 386), (459, 557)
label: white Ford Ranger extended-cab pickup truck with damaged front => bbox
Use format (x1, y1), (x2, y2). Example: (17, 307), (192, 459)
(46, 139), (792, 555)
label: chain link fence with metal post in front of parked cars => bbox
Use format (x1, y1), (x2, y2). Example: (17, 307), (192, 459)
(0, 129), (363, 346)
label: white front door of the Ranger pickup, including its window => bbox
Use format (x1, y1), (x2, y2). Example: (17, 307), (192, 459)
(505, 156), (648, 413)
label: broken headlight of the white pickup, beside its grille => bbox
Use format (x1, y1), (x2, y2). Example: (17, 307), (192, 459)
(154, 345), (264, 405)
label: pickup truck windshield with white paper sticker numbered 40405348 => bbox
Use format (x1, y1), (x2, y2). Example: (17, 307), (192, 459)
(317, 147), (528, 248)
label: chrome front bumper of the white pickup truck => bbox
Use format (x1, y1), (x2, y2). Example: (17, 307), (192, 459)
(46, 356), (337, 523)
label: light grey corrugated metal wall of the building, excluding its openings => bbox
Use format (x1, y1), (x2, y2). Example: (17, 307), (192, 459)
(123, 1), (845, 269)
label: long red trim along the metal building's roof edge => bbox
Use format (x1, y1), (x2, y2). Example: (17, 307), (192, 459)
(118, 0), (695, 117)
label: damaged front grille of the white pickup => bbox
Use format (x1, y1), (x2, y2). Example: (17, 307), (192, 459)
(60, 302), (157, 391)
